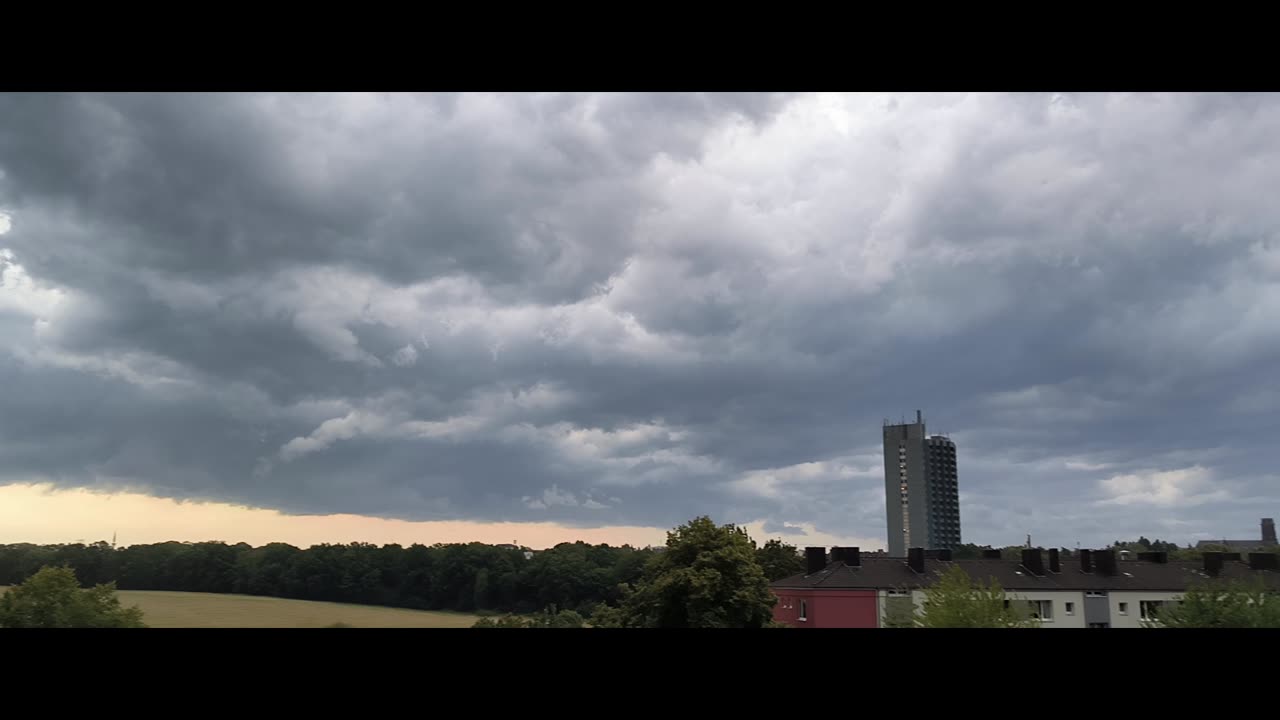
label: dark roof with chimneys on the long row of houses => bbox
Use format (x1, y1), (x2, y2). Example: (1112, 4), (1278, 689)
(772, 557), (1280, 592)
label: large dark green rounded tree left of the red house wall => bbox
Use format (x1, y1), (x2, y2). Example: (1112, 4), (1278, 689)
(593, 516), (777, 628)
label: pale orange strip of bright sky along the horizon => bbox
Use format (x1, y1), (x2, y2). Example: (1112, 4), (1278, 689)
(0, 483), (882, 550)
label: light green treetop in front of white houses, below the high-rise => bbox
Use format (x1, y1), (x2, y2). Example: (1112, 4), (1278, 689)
(918, 565), (1039, 628)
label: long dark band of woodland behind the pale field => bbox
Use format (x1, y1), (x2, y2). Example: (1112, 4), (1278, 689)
(0, 520), (804, 616)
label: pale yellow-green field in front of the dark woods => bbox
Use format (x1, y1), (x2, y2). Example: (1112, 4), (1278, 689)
(0, 587), (479, 628)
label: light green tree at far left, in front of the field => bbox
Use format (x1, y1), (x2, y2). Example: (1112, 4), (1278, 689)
(0, 568), (146, 628)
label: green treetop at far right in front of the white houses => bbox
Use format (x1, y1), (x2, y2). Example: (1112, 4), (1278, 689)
(1158, 580), (1280, 628)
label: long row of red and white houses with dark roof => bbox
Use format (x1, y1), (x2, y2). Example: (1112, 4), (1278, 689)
(772, 547), (1280, 628)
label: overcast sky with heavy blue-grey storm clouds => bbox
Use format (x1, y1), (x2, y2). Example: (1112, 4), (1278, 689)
(0, 94), (1280, 547)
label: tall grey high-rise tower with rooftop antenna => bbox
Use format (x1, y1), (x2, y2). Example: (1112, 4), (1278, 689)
(883, 410), (960, 557)
